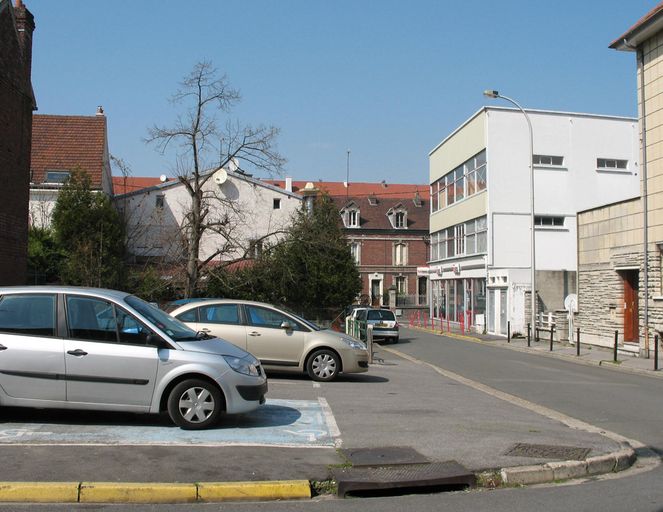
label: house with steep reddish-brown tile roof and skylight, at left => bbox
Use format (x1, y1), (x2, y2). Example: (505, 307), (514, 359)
(29, 107), (113, 226)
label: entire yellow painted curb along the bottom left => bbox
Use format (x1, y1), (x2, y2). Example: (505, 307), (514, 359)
(0, 480), (311, 503)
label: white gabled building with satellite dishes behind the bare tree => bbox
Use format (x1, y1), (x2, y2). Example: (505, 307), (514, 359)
(114, 169), (303, 263)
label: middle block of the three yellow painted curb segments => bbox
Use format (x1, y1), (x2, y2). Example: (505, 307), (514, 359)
(79, 482), (198, 503)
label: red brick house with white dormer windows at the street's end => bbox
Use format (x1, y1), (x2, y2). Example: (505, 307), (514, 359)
(271, 180), (430, 307)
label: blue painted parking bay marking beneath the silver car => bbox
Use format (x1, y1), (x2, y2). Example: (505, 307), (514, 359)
(0, 400), (340, 447)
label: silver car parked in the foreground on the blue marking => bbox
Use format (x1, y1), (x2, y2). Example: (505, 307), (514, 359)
(0, 286), (267, 429)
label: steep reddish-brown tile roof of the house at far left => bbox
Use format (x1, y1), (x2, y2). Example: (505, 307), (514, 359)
(30, 114), (107, 189)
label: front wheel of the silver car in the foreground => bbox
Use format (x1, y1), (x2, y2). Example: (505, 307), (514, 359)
(168, 379), (223, 430)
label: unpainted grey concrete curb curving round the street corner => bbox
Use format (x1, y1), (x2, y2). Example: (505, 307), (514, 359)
(499, 447), (636, 485)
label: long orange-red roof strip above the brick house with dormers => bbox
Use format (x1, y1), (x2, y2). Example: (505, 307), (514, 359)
(264, 180), (430, 200)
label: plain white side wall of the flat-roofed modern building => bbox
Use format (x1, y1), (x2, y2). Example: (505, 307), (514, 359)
(486, 109), (640, 270)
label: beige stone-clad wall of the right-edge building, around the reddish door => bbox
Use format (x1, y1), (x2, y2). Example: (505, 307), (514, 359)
(578, 28), (663, 354)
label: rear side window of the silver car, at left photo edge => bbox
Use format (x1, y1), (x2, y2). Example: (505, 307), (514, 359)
(0, 295), (55, 336)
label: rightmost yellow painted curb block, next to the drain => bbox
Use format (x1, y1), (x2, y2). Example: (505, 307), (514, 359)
(198, 480), (311, 502)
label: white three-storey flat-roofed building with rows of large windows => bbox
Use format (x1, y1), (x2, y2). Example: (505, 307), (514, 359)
(428, 107), (639, 334)
